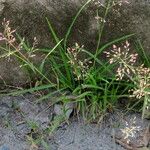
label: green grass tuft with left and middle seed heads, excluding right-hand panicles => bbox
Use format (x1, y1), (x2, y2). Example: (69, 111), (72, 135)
(0, 0), (139, 124)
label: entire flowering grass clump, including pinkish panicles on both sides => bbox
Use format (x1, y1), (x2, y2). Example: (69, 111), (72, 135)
(1, 0), (149, 124)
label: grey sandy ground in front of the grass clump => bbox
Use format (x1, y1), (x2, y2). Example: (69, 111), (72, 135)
(0, 94), (149, 150)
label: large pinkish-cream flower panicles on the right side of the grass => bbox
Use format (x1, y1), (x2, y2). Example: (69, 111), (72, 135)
(104, 41), (150, 119)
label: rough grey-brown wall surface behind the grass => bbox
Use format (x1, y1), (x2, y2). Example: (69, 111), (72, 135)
(0, 0), (150, 84)
